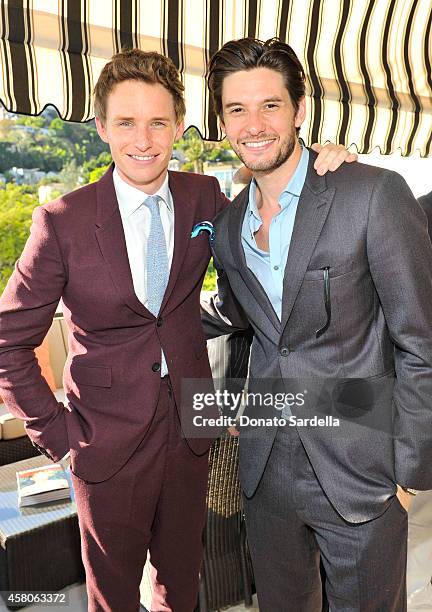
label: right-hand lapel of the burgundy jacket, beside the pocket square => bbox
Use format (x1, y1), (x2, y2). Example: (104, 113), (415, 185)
(161, 172), (197, 312)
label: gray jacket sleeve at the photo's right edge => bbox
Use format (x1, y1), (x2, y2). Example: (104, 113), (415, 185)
(367, 172), (432, 489)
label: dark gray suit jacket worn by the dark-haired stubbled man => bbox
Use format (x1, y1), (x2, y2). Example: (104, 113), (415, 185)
(203, 152), (432, 522)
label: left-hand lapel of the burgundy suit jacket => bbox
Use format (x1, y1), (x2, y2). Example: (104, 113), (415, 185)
(96, 166), (153, 318)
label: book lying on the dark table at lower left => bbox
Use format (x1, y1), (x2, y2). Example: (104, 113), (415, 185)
(16, 463), (70, 507)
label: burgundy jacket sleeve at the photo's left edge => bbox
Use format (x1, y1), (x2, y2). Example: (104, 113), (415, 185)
(0, 207), (69, 461)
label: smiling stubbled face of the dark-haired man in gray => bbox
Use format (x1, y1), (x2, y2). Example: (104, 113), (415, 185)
(222, 68), (305, 172)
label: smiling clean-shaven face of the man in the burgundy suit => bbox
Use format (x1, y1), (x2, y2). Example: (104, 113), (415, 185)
(96, 80), (183, 195)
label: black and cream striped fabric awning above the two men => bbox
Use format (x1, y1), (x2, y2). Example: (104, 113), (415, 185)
(0, 0), (432, 155)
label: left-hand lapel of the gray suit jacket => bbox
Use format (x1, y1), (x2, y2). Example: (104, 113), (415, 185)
(228, 187), (281, 334)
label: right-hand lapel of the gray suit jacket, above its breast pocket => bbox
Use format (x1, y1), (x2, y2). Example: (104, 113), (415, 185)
(282, 161), (335, 330)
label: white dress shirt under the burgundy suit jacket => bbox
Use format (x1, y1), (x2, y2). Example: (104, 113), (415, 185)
(113, 168), (174, 376)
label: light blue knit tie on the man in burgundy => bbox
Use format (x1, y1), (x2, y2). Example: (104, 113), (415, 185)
(144, 196), (169, 317)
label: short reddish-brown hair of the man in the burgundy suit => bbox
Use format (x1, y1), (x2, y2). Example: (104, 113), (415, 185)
(94, 49), (186, 123)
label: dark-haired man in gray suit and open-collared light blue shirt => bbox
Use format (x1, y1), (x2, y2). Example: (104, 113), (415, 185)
(203, 39), (432, 612)
